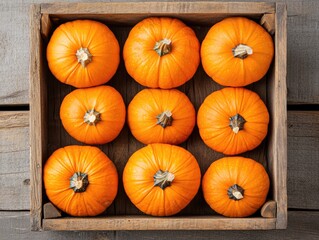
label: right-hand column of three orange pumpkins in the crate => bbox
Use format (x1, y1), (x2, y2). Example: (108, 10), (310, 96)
(197, 17), (274, 217)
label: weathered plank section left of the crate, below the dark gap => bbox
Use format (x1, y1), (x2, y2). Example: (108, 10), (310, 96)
(0, 112), (30, 210)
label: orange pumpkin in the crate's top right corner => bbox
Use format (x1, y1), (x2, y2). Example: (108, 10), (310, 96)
(201, 17), (274, 87)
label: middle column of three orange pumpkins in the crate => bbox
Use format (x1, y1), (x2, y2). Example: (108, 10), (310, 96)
(123, 17), (201, 216)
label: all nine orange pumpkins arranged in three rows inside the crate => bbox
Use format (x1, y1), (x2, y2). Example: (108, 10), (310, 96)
(44, 17), (274, 217)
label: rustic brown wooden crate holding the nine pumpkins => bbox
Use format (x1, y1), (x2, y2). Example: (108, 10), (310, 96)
(30, 2), (287, 231)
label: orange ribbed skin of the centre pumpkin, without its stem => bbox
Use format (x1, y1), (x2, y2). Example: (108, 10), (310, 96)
(127, 89), (196, 145)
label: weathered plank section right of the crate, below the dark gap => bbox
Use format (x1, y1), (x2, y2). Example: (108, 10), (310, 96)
(288, 111), (319, 209)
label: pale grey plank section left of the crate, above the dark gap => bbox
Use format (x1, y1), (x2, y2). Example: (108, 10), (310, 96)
(0, 0), (29, 105)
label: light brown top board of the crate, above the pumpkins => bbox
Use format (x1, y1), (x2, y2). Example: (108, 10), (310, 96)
(41, 1), (275, 15)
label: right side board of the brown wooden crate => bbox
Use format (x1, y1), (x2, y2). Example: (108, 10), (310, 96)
(267, 3), (287, 229)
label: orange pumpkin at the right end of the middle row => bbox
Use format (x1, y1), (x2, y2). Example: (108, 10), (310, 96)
(197, 88), (269, 155)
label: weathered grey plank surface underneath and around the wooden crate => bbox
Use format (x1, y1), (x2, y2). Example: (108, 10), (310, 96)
(0, 0), (319, 240)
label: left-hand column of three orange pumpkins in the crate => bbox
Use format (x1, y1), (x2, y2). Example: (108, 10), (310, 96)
(44, 20), (126, 216)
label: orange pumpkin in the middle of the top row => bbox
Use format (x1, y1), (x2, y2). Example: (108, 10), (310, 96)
(123, 17), (200, 89)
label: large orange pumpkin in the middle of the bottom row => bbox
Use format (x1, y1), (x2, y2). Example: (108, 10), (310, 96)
(123, 143), (201, 216)
